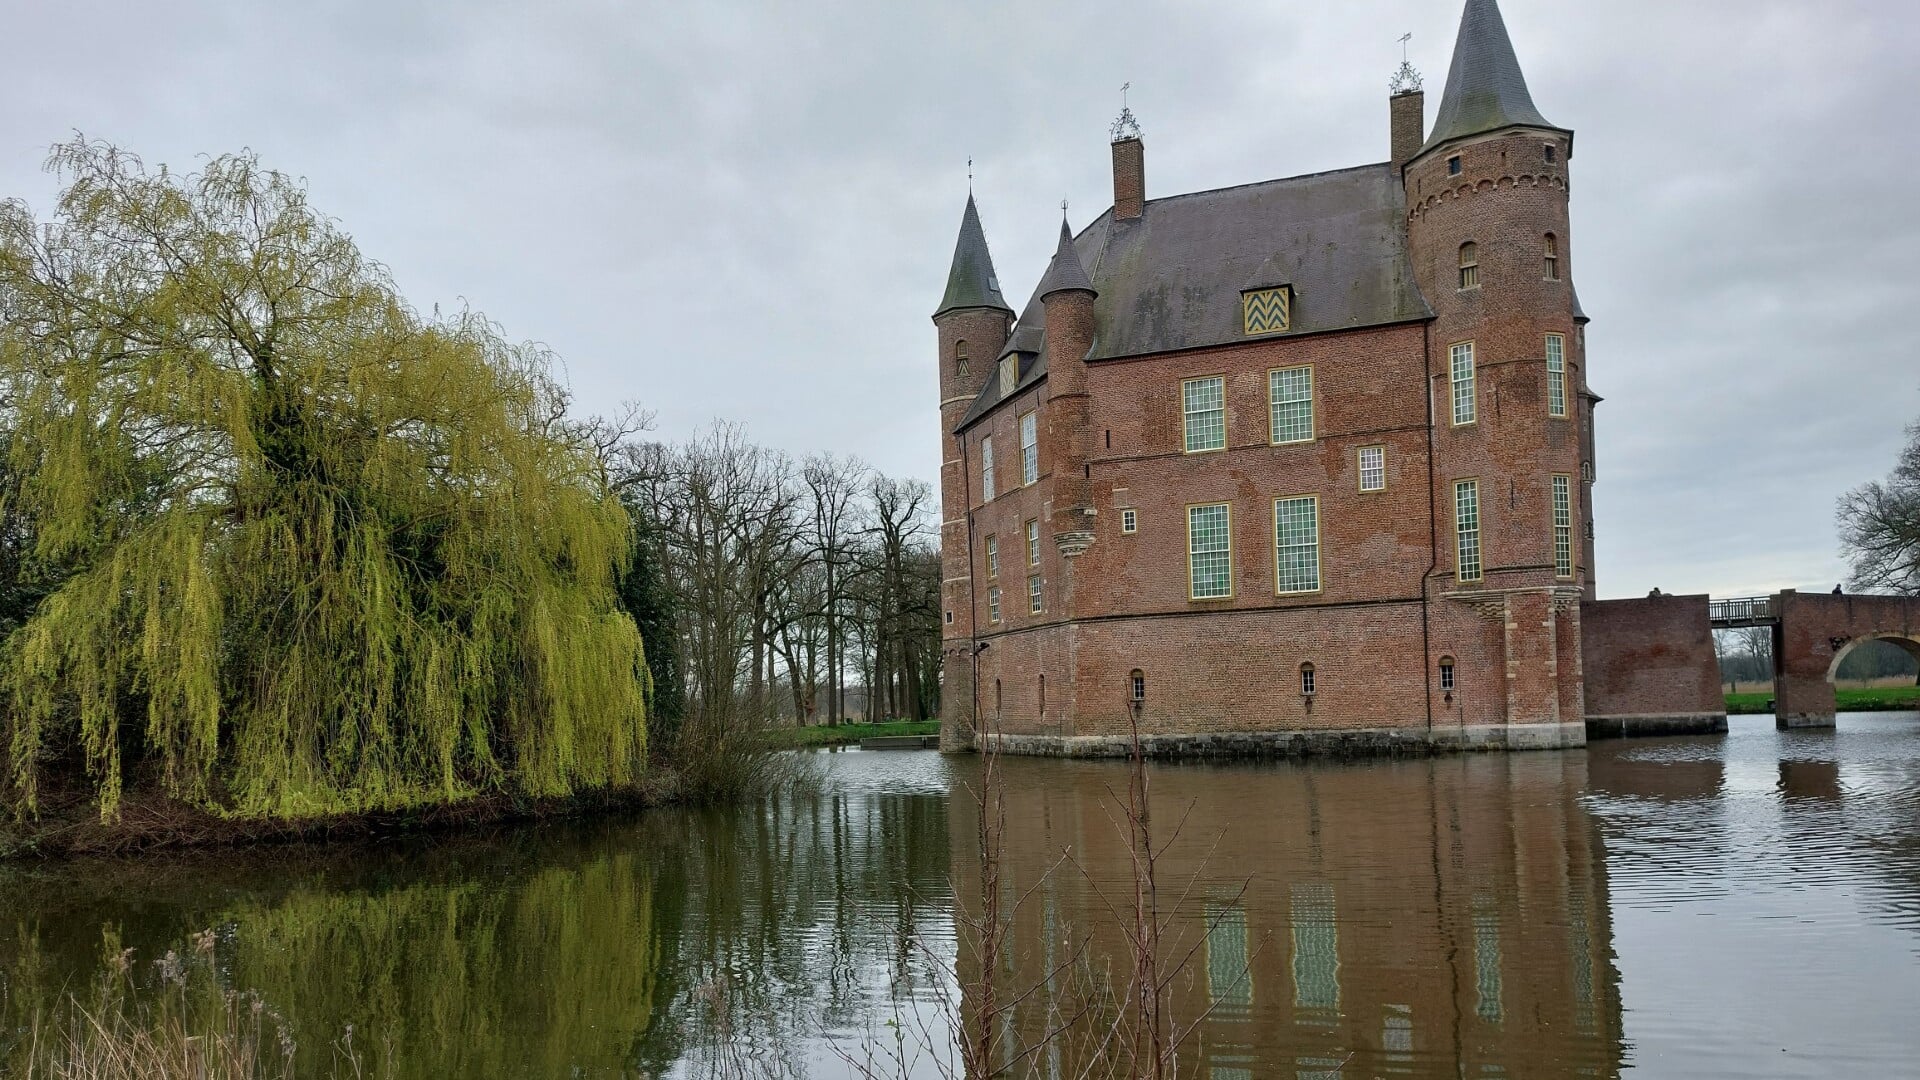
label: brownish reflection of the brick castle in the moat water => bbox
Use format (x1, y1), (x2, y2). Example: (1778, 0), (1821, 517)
(948, 753), (1628, 1080)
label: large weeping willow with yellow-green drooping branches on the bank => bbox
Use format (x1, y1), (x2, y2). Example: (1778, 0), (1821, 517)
(0, 140), (647, 819)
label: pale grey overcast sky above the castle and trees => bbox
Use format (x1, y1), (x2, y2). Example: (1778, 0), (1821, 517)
(0, 0), (1920, 596)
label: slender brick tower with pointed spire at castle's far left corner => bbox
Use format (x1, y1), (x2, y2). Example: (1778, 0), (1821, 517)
(933, 192), (1014, 749)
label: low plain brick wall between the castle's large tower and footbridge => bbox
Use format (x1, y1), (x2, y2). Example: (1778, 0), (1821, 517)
(1580, 596), (1726, 717)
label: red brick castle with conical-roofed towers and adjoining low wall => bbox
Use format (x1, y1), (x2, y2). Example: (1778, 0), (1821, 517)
(933, 0), (1726, 753)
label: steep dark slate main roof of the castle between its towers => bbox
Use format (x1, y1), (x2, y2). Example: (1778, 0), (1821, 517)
(960, 163), (1432, 429)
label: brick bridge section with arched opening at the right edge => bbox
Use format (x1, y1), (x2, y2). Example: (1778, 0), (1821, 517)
(1772, 590), (1920, 728)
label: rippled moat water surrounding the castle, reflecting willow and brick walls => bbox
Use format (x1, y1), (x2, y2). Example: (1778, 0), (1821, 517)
(0, 713), (1920, 1080)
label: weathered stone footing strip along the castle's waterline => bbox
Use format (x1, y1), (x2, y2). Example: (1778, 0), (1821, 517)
(975, 723), (1586, 757)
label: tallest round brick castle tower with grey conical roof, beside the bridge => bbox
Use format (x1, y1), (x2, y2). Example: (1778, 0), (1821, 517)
(1394, 0), (1590, 730)
